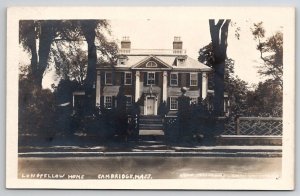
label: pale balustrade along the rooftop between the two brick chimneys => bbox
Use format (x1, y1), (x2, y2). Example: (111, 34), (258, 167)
(119, 48), (186, 55)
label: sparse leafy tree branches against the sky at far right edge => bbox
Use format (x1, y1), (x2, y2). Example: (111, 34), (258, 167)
(251, 22), (283, 88)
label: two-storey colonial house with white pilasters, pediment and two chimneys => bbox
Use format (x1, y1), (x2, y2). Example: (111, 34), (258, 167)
(95, 37), (211, 115)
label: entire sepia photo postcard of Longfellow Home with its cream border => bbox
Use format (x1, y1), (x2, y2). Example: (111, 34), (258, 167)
(6, 7), (295, 190)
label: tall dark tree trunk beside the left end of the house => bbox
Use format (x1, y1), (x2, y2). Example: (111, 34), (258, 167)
(81, 20), (98, 112)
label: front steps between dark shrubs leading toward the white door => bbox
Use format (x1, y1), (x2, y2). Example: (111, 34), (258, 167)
(139, 116), (164, 136)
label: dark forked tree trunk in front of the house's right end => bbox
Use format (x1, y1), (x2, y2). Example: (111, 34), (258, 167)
(209, 19), (230, 116)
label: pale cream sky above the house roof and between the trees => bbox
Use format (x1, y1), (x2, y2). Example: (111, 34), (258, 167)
(21, 18), (283, 88)
